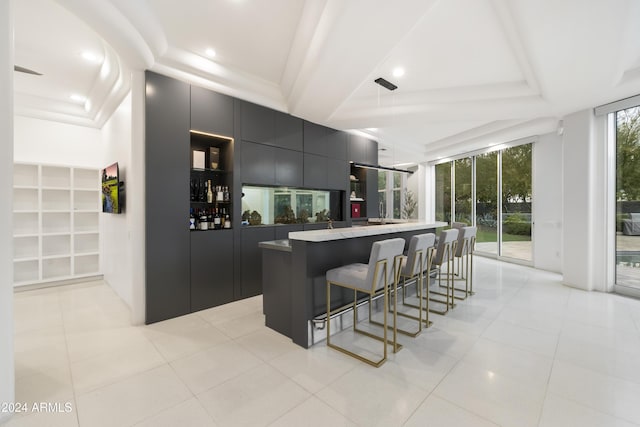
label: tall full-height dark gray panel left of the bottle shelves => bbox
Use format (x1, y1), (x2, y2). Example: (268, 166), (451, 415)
(145, 71), (191, 323)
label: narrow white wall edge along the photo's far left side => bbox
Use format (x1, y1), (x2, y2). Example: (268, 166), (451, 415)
(0, 0), (15, 423)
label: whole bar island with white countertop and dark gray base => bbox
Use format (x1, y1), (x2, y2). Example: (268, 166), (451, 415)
(259, 222), (448, 348)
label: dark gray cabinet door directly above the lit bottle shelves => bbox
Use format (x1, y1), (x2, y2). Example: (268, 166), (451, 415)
(191, 86), (233, 137)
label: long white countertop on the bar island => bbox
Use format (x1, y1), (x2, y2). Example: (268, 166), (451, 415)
(289, 221), (449, 242)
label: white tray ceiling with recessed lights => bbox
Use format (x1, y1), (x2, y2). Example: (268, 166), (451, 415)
(14, 0), (640, 165)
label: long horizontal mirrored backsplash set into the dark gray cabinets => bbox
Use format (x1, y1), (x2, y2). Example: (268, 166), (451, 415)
(242, 185), (344, 225)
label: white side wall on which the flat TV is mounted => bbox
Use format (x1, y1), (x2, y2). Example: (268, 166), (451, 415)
(100, 94), (133, 316)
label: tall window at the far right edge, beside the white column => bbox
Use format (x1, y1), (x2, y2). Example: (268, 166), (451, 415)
(615, 107), (640, 288)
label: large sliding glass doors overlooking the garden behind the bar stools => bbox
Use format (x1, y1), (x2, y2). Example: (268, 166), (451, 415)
(435, 144), (532, 261)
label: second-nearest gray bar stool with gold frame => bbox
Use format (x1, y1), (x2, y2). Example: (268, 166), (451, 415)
(394, 233), (436, 337)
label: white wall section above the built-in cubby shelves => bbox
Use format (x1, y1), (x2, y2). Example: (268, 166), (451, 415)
(14, 116), (104, 168)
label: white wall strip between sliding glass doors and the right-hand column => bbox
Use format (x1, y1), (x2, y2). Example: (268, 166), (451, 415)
(533, 133), (563, 273)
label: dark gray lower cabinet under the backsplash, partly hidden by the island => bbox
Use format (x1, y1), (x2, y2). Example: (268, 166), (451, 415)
(240, 226), (275, 298)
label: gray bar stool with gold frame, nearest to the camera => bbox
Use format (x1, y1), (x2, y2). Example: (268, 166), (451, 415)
(326, 238), (405, 367)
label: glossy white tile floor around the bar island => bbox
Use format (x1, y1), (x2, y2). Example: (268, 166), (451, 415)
(7, 257), (640, 427)
